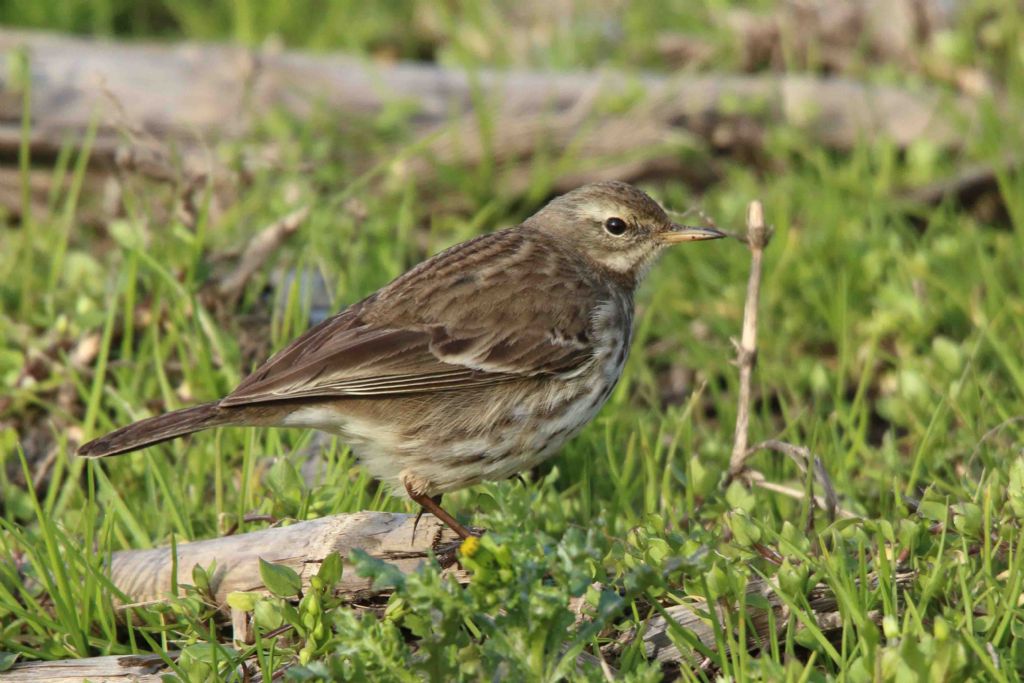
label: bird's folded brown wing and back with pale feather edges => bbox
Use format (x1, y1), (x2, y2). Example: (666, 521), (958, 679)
(221, 233), (596, 407)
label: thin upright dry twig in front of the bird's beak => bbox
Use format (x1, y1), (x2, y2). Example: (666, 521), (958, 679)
(727, 200), (771, 481)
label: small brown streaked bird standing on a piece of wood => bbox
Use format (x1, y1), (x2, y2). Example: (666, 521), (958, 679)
(79, 182), (725, 538)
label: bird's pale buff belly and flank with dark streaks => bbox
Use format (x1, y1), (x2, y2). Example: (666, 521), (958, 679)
(282, 327), (629, 495)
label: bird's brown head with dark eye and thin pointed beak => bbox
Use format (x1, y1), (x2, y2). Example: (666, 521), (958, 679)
(525, 181), (725, 284)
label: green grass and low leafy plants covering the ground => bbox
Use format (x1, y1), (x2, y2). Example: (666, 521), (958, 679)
(0, 1), (1024, 681)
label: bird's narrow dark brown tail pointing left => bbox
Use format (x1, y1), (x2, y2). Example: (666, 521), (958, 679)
(78, 401), (234, 458)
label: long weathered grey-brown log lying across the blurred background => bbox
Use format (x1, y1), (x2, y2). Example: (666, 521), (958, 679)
(0, 30), (973, 184)
